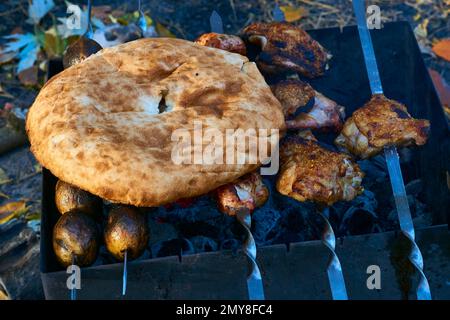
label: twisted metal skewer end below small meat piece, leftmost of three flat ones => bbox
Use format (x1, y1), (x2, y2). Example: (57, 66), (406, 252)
(236, 208), (265, 300)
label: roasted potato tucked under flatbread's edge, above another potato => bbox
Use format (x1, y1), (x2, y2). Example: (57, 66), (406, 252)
(55, 180), (102, 218)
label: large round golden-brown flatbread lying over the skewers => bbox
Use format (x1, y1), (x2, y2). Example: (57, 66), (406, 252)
(26, 38), (284, 206)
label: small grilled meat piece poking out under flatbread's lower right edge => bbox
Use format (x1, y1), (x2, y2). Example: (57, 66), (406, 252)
(216, 172), (269, 216)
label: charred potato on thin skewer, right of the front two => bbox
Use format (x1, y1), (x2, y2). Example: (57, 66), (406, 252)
(104, 206), (149, 261)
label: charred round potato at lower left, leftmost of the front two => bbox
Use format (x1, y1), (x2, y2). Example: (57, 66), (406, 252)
(53, 210), (100, 267)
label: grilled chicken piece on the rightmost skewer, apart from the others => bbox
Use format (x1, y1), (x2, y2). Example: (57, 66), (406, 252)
(335, 94), (430, 159)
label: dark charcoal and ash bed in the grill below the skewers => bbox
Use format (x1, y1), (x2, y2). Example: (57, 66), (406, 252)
(141, 156), (432, 257)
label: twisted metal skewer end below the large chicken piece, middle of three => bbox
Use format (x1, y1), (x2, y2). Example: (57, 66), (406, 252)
(318, 207), (348, 300)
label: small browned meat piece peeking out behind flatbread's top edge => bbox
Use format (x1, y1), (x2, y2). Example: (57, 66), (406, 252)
(195, 32), (247, 56)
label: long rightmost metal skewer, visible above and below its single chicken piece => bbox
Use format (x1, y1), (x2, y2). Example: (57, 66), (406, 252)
(353, 0), (431, 300)
